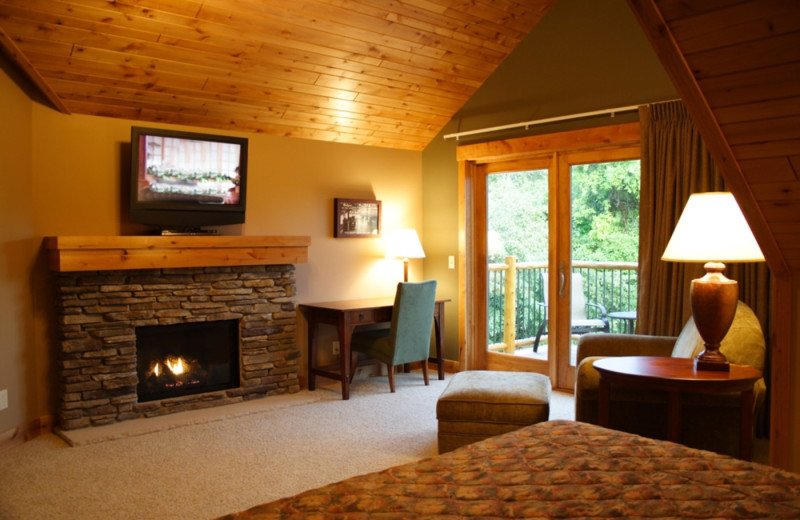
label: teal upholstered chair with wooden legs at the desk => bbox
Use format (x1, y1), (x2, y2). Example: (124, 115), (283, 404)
(350, 280), (436, 392)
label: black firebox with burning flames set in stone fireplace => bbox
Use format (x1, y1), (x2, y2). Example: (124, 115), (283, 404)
(136, 320), (239, 402)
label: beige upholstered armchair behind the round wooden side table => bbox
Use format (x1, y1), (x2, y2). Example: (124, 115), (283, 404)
(575, 302), (766, 456)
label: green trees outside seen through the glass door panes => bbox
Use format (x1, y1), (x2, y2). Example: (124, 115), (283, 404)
(487, 160), (641, 350)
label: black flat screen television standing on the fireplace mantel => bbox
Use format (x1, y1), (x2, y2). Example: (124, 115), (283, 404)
(129, 126), (247, 232)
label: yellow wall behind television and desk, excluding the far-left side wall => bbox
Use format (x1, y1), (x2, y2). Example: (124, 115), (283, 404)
(28, 106), (422, 300)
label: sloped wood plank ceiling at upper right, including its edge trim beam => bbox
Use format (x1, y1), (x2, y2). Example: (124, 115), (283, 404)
(628, 0), (800, 275)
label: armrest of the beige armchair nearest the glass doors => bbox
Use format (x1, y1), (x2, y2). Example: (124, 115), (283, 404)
(576, 333), (677, 364)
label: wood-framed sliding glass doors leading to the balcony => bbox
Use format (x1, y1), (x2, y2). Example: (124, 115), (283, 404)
(459, 124), (639, 389)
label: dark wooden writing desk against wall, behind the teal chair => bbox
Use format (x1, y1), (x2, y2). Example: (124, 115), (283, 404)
(299, 296), (450, 399)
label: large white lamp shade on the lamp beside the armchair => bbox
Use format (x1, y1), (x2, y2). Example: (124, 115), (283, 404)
(661, 192), (764, 262)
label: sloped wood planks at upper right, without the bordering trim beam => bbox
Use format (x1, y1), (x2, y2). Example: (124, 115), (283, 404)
(657, 0), (800, 270)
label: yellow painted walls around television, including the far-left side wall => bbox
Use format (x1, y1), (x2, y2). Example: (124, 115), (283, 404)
(0, 67), (423, 441)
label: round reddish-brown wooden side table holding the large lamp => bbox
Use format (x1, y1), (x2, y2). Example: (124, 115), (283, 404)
(594, 356), (761, 460)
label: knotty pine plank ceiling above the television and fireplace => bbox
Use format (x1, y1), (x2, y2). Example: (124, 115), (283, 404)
(0, 0), (556, 150)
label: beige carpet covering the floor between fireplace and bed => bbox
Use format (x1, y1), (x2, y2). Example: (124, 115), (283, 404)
(0, 373), (574, 520)
